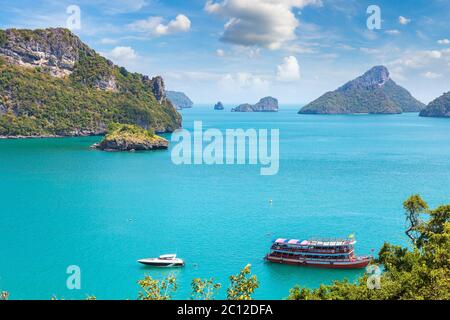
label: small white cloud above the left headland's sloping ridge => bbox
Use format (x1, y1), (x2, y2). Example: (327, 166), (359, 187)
(128, 14), (191, 36)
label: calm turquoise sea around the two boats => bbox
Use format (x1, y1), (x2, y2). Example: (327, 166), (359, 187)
(0, 106), (450, 299)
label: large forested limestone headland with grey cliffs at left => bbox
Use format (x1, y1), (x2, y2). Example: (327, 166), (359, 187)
(0, 28), (181, 137)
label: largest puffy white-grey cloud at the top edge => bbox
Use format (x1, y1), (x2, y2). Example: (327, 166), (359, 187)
(205, 0), (322, 50)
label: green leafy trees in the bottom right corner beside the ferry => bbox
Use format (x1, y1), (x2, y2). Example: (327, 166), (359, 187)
(288, 195), (450, 300)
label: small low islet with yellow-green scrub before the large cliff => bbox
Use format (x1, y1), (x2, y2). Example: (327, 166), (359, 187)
(91, 123), (169, 151)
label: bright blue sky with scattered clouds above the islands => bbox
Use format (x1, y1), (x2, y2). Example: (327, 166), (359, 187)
(0, 0), (450, 104)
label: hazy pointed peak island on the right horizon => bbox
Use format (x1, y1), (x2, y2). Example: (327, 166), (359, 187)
(299, 66), (425, 114)
